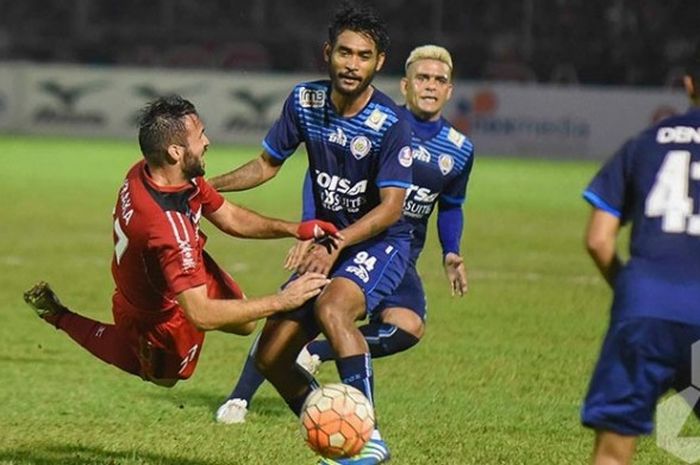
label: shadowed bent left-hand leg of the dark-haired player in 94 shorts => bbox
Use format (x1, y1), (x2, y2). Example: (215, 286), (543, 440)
(255, 302), (318, 416)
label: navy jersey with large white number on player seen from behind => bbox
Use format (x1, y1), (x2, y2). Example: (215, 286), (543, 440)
(584, 109), (700, 325)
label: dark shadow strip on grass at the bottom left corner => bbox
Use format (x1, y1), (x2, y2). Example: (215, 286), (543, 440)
(0, 445), (220, 465)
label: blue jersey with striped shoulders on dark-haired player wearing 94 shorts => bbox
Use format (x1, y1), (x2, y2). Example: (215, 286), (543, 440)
(263, 81), (413, 237)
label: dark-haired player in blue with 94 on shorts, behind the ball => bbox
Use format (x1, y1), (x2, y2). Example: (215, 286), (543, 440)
(212, 7), (413, 464)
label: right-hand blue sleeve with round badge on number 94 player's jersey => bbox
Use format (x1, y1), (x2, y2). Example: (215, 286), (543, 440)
(376, 119), (413, 189)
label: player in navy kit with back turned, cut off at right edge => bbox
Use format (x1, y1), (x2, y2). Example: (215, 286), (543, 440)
(581, 54), (700, 465)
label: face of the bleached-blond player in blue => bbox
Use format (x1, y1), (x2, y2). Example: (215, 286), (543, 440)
(401, 59), (452, 120)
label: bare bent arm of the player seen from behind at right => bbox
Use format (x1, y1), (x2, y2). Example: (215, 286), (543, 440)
(586, 208), (622, 287)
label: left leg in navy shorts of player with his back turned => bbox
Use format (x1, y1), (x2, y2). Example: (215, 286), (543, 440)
(581, 318), (679, 465)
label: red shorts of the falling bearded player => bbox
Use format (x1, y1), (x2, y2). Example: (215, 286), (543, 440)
(112, 254), (243, 380)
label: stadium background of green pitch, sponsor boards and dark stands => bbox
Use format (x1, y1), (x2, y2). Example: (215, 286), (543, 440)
(0, 0), (700, 465)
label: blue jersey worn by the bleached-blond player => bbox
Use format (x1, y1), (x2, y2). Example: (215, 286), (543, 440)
(401, 108), (474, 263)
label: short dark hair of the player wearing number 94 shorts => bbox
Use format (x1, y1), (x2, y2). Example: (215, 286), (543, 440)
(328, 3), (389, 53)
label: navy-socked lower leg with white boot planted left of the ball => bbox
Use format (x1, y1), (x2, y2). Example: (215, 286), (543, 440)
(216, 334), (265, 424)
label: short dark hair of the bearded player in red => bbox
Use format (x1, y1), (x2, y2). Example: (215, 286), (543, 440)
(139, 95), (197, 166)
